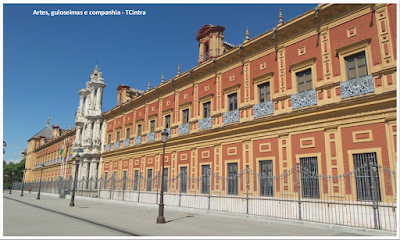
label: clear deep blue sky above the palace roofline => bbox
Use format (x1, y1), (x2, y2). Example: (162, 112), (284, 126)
(2, 3), (317, 161)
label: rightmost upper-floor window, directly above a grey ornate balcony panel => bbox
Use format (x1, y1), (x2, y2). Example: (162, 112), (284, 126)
(344, 52), (368, 79)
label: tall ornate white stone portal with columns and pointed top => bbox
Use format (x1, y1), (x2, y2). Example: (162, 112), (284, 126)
(72, 65), (107, 187)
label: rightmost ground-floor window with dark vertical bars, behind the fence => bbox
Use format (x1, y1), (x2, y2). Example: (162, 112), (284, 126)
(353, 153), (381, 201)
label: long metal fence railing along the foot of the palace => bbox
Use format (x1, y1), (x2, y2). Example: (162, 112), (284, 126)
(13, 163), (397, 231)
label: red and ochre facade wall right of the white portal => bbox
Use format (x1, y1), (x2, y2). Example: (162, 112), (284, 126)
(101, 4), (397, 201)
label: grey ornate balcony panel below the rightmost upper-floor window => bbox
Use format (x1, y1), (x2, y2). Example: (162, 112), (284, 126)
(340, 75), (375, 99)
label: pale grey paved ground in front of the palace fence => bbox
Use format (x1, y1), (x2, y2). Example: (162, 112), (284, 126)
(3, 191), (396, 237)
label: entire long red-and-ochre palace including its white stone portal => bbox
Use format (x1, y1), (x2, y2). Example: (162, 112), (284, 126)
(22, 4), (398, 231)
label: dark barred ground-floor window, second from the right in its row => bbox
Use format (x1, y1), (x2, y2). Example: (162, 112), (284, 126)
(300, 157), (319, 198)
